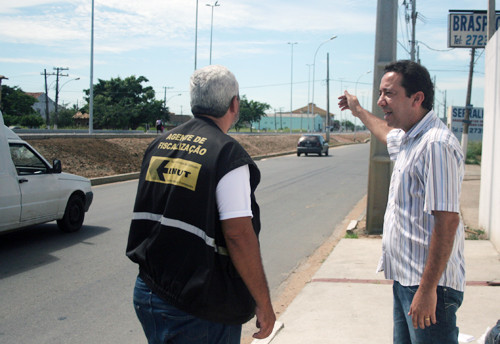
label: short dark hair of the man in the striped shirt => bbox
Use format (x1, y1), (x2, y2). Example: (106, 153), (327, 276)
(384, 60), (434, 111)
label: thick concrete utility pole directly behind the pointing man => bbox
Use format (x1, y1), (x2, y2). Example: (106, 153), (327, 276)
(366, 0), (398, 234)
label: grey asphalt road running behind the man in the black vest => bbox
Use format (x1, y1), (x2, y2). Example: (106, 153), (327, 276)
(0, 144), (369, 344)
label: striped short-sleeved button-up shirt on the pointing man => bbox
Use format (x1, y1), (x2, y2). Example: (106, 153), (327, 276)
(377, 111), (465, 291)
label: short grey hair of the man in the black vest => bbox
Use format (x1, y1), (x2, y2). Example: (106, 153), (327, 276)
(190, 65), (239, 117)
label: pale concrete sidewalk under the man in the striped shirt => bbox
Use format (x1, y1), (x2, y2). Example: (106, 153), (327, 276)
(252, 165), (500, 344)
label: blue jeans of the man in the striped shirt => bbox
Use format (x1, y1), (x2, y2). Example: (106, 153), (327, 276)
(393, 281), (464, 344)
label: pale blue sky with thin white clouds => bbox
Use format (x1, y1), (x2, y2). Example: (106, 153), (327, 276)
(0, 0), (499, 120)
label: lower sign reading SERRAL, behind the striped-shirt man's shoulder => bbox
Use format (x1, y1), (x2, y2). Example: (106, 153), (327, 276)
(448, 106), (483, 141)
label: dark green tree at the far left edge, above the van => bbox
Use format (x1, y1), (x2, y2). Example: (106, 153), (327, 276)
(2, 85), (39, 127)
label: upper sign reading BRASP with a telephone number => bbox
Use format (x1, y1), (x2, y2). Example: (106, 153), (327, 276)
(448, 10), (500, 48)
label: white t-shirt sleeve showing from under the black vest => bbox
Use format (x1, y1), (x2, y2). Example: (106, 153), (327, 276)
(215, 165), (253, 220)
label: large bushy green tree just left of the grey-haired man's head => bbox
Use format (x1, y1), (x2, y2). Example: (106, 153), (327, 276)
(84, 75), (169, 129)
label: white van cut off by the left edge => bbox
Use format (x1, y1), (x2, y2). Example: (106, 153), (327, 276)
(0, 112), (93, 232)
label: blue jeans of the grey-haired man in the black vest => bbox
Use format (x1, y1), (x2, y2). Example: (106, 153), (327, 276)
(134, 277), (241, 344)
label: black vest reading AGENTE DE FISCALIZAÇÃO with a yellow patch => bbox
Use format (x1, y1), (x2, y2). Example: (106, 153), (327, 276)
(127, 117), (260, 324)
